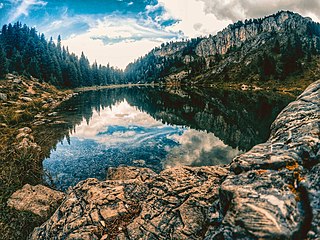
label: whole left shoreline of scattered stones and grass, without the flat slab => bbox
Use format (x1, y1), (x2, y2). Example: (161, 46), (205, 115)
(0, 74), (74, 239)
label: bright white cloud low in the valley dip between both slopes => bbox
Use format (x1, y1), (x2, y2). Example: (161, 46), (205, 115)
(63, 16), (179, 69)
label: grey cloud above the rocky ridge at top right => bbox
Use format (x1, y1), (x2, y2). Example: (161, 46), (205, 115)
(199, 0), (320, 21)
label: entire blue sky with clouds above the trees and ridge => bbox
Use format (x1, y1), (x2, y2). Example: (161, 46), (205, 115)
(0, 0), (320, 69)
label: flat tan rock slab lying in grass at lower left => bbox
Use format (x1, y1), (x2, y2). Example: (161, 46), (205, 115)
(8, 184), (64, 218)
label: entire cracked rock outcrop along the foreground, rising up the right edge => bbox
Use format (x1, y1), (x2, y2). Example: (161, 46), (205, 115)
(30, 81), (320, 239)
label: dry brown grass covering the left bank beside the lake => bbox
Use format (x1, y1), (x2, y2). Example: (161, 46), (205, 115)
(0, 74), (71, 240)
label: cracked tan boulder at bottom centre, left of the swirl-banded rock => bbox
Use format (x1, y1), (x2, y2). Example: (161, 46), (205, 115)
(31, 167), (227, 239)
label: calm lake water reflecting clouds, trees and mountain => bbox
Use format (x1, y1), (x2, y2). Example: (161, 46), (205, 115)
(43, 88), (293, 190)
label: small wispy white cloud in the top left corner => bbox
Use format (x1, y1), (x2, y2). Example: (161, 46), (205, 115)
(8, 0), (47, 22)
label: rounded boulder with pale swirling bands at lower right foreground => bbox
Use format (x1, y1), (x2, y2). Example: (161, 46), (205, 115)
(207, 170), (303, 239)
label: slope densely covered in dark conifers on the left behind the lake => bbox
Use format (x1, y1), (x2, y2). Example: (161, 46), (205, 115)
(0, 22), (124, 88)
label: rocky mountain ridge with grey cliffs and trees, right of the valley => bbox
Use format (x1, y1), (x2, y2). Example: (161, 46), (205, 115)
(125, 11), (320, 84)
